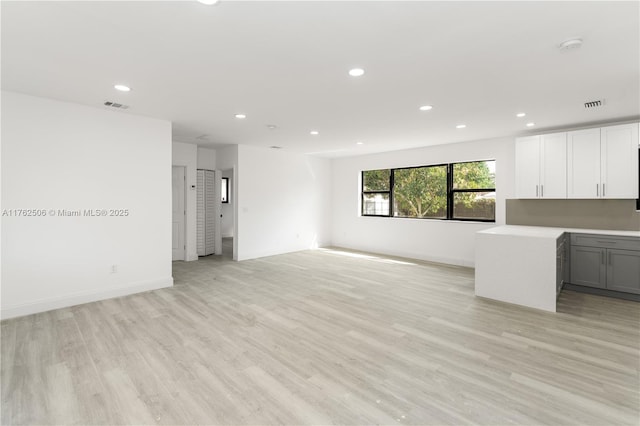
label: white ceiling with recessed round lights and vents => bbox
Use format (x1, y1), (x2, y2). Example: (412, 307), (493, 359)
(1, 1), (640, 157)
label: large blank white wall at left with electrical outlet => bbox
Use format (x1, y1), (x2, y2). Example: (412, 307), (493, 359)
(1, 92), (173, 318)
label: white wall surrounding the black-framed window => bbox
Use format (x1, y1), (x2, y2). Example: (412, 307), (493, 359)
(332, 138), (514, 266)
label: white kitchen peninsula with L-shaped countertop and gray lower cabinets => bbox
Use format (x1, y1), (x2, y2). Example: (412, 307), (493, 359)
(475, 225), (640, 312)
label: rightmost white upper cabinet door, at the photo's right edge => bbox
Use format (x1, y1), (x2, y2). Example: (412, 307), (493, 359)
(601, 123), (638, 199)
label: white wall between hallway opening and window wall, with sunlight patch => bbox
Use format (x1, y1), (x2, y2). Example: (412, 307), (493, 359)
(236, 145), (331, 260)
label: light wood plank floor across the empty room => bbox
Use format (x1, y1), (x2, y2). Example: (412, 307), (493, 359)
(1, 245), (640, 425)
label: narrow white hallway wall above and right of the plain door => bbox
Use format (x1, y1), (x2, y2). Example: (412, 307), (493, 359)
(171, 142), (198, 261)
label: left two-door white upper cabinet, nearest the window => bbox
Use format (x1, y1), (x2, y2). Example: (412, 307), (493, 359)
(516, 133), (567, 198)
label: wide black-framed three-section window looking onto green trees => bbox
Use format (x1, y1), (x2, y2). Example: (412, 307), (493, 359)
(362, 160), (496, 222)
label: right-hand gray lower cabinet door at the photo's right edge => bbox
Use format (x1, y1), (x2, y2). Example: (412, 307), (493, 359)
(607, 249), (640, 294)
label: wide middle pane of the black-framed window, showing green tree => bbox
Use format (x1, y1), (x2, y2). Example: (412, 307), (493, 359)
(393, 166), (447, 218)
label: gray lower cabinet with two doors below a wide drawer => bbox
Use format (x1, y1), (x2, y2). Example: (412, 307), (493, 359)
(570, 234), (640, 294)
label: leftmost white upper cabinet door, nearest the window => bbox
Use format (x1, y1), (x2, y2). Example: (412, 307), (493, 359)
(516, 136), (540, 198)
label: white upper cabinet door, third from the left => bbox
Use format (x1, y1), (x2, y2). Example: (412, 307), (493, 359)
(567, 129), (602, 198)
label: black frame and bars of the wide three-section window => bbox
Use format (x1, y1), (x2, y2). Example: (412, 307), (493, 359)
(360, 159), (496, 223)
